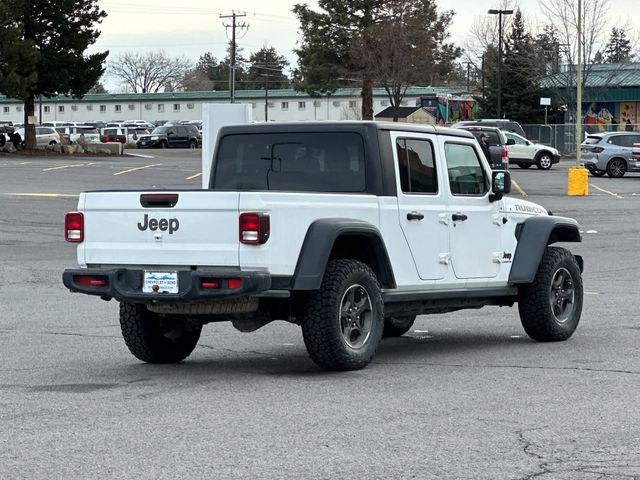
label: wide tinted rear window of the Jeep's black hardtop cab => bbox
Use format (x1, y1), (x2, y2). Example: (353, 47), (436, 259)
(212, 132), (366, 192)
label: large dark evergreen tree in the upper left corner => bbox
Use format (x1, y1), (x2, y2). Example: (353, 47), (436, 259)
(0, 0), (109, 148)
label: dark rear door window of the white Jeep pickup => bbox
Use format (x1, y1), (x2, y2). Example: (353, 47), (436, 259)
(396, 138), (438, 193)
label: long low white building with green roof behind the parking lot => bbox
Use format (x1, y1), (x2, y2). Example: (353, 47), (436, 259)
(0, 87), (454, 124)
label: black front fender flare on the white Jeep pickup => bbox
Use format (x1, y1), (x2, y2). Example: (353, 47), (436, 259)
(509, 216), (584, 284)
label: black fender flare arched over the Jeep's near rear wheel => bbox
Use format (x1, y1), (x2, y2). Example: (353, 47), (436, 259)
(292, 218), (396, 290)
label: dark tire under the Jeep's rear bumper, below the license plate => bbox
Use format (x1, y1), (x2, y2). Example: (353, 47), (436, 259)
(120, 303), (202, 363)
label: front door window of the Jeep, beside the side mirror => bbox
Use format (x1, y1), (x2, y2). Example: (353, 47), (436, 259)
(444, 143), (489, 195)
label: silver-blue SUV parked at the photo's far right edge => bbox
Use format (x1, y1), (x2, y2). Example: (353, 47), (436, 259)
(581, 132), (640, 178)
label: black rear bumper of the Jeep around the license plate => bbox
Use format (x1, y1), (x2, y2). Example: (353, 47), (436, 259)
(62, 268), (271, 303)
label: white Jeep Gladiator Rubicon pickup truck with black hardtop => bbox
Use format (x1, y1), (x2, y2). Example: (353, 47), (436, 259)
(63, 122), (583, 370)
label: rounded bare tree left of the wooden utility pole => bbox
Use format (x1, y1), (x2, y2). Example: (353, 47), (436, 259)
(108, 51), (191, 93)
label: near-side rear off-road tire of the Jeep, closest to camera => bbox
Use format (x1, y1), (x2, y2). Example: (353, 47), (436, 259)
(302, 259), (384, 370)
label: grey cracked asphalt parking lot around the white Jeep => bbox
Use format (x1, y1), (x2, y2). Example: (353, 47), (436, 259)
(0, 150), (640, 480)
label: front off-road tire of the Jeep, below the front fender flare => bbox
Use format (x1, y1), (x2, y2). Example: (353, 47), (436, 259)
(518, 247), (584, 342)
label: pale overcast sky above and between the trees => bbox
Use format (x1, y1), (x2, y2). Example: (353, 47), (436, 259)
(92, 0), (640, 88)
